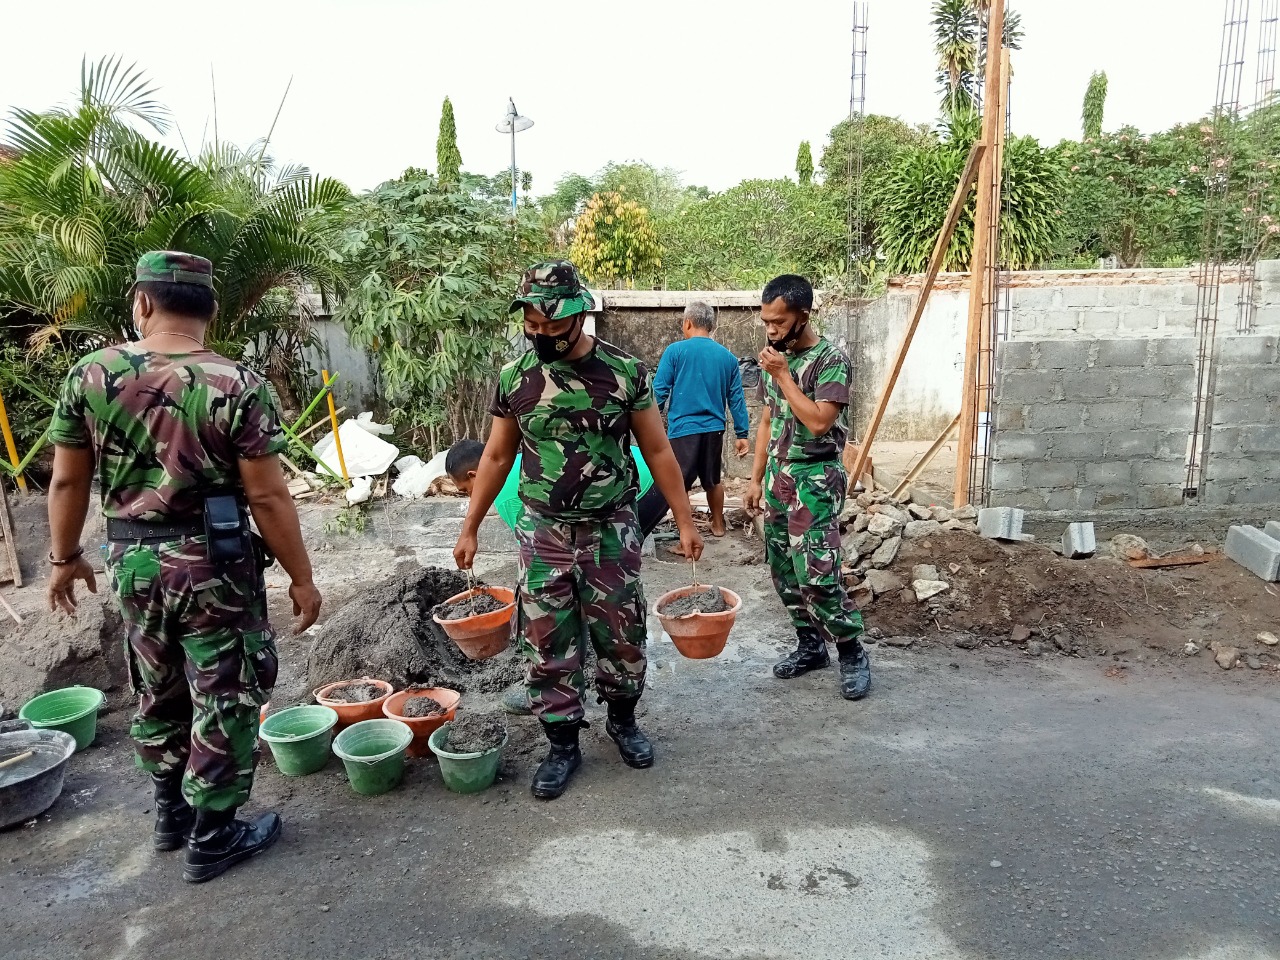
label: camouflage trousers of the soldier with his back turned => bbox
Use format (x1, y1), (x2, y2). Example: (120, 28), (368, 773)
(108, 538), (278, 810)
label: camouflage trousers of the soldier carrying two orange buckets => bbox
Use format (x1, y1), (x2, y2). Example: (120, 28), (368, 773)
(515, 506), (648, 723)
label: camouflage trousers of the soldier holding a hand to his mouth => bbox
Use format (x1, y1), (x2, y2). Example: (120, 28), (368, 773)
(764, 461), (863, 644)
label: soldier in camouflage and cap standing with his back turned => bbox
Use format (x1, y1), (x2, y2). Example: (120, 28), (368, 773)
(49, 251), (320, 883)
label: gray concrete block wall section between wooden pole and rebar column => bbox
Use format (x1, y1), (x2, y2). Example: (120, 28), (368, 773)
(991, 338), (1192, 509)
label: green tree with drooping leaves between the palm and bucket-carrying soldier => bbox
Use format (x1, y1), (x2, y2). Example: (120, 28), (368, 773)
(335, 170), (536, 451)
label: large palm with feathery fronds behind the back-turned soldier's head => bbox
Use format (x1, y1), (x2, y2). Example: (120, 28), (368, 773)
(0, 59), (349, 402)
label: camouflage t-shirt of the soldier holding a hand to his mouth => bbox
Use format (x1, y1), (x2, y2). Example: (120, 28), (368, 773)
(765, 337), (852, 461)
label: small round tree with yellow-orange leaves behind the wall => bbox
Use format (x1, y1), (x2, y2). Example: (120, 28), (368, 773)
(570, 191), (662, 283)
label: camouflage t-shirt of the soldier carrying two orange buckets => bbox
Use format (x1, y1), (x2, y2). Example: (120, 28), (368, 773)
(490, 338), (653, 522)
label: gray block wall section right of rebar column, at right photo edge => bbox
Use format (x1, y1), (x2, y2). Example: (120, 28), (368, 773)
(1201, 334), (1280, 506)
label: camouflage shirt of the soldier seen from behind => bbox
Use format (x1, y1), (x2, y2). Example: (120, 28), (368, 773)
(49, 344), (285, 521)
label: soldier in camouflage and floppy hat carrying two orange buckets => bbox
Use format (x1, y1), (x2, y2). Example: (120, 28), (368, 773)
(454, 260), (703, 799)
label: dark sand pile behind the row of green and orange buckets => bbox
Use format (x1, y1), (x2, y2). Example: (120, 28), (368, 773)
(307, 567), (524, 692)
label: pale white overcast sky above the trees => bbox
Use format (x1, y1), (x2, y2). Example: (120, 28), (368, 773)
(0, 0), (1239, 192)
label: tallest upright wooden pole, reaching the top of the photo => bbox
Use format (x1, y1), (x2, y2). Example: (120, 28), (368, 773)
(954, 0), (1005, 508)
